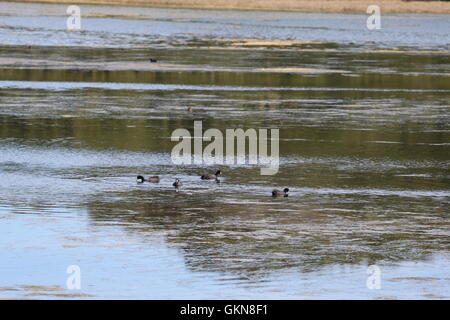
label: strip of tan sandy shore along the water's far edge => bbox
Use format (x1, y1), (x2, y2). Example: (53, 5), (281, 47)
(2, 0), (450, 14)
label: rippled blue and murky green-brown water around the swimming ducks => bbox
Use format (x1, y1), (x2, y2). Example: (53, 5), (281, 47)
(0, 3), (450, 299)
